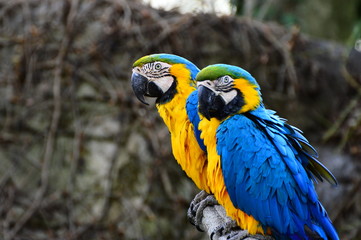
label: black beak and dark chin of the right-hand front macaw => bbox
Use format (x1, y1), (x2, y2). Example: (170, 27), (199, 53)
(198, 85), (226, 120)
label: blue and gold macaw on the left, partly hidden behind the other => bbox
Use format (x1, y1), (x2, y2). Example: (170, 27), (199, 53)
(131, 54), (210, 193)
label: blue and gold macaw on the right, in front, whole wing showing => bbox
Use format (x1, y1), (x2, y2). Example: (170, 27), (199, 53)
(196, 64), (339, 240)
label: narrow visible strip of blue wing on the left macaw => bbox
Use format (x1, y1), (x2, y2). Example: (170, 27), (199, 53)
(186, 90), (207, 151)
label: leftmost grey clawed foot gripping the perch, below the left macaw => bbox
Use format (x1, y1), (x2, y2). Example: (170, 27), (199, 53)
(187, 191), (218, 232)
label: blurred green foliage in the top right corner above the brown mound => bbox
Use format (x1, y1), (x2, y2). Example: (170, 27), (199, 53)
(230, 0), (361, 43)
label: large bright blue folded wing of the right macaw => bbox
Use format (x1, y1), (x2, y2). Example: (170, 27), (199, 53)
(216, 109), (338, 239)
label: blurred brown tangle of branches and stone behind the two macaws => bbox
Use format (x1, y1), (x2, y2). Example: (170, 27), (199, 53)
(0, 0), (361, 240)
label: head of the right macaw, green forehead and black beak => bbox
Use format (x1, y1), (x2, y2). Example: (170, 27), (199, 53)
(196, 64), (262, 120)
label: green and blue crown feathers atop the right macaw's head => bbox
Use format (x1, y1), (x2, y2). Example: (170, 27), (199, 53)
(196, 64), (258, 85)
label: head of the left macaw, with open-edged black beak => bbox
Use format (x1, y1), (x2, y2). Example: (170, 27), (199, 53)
(132, 54), (199, 105)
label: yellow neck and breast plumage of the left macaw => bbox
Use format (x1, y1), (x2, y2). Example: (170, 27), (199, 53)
(157, 64), (209, 192)
